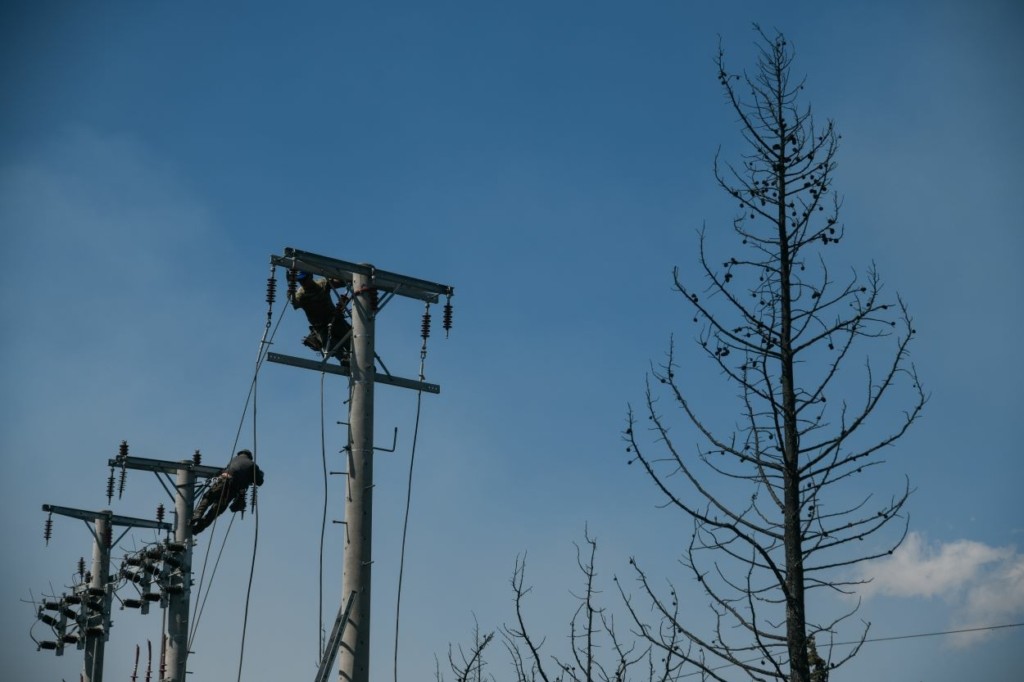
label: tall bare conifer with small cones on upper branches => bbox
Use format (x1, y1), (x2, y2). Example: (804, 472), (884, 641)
(623, 27), (927, 682)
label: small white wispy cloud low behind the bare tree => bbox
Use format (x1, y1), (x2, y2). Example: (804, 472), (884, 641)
(860, 532), (1024, 646)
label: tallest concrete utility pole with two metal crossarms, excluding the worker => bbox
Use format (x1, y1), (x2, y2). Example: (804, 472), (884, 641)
(267, 248), (455, 682)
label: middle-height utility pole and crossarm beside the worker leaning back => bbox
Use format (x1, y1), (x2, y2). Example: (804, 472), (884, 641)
(110, 448), (221, 682)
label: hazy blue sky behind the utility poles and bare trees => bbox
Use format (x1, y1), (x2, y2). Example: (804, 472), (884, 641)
(0, 0), (1024, 682)
